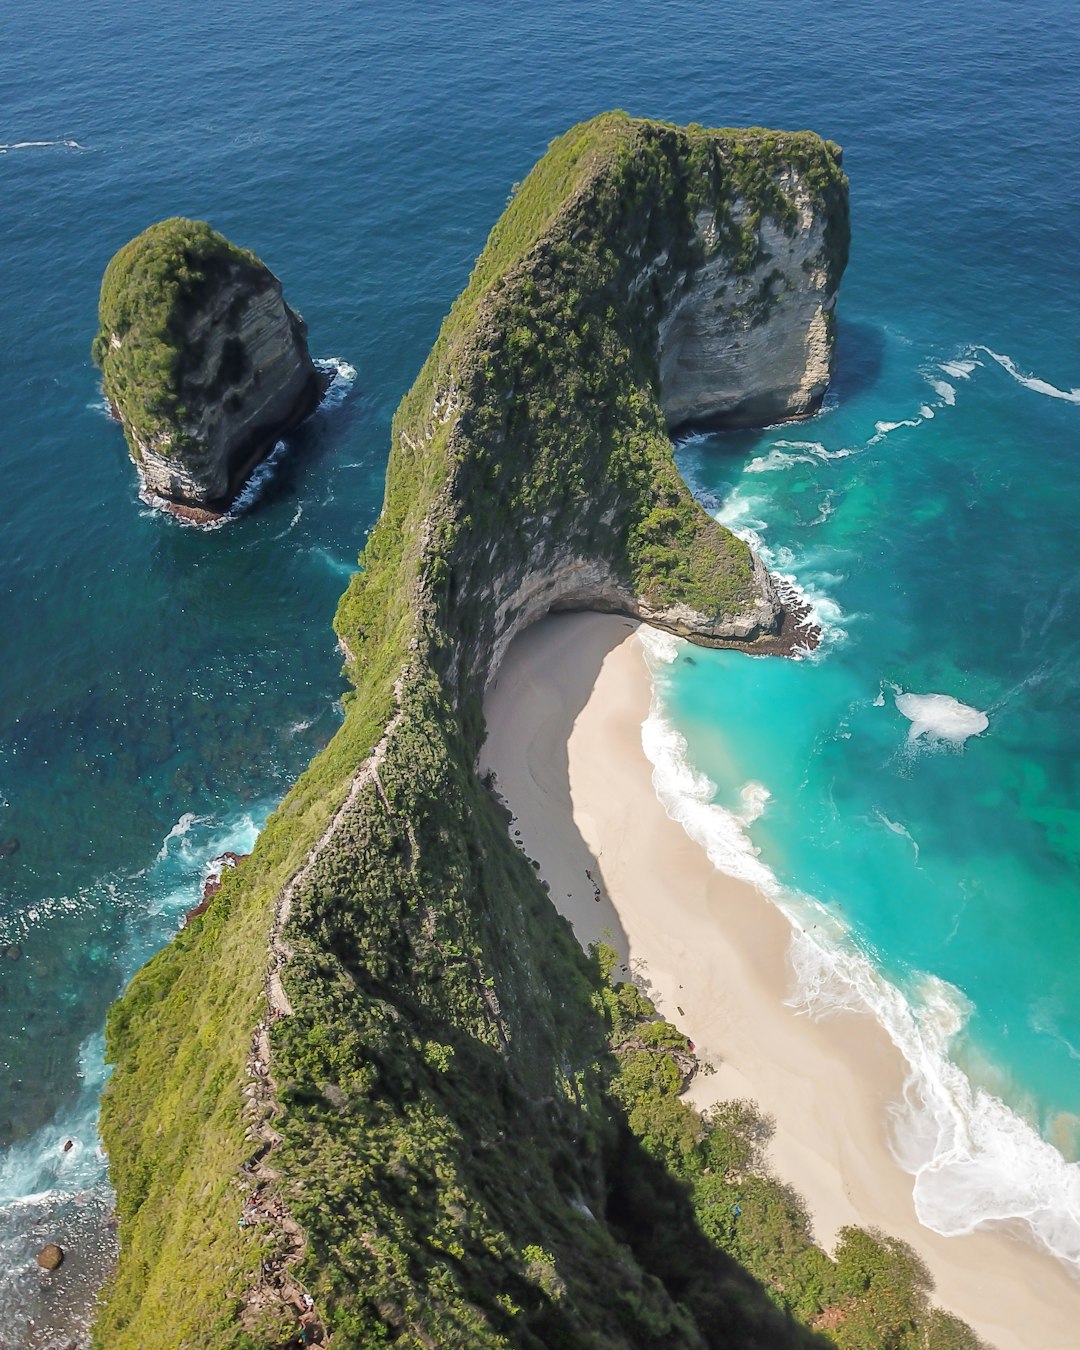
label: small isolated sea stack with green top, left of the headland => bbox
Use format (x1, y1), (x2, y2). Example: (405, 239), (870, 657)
(93, 216), (325, 520)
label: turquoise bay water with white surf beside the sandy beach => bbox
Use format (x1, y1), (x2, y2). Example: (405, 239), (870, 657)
(659, 321), (1080, 1261)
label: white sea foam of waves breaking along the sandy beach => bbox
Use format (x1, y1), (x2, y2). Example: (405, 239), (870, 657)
(639, 626), (1080, 1272)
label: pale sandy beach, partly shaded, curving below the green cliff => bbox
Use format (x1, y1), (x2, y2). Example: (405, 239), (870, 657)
(481, 614), (1080, 1350)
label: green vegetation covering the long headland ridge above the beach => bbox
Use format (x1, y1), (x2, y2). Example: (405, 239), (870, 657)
(96, 113), (975, 1350)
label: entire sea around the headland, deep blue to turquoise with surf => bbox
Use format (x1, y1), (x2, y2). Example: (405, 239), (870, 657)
(0, 0), (1080, 1346)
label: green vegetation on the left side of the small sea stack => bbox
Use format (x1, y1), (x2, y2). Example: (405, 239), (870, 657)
(92, 216), (270, 459)
